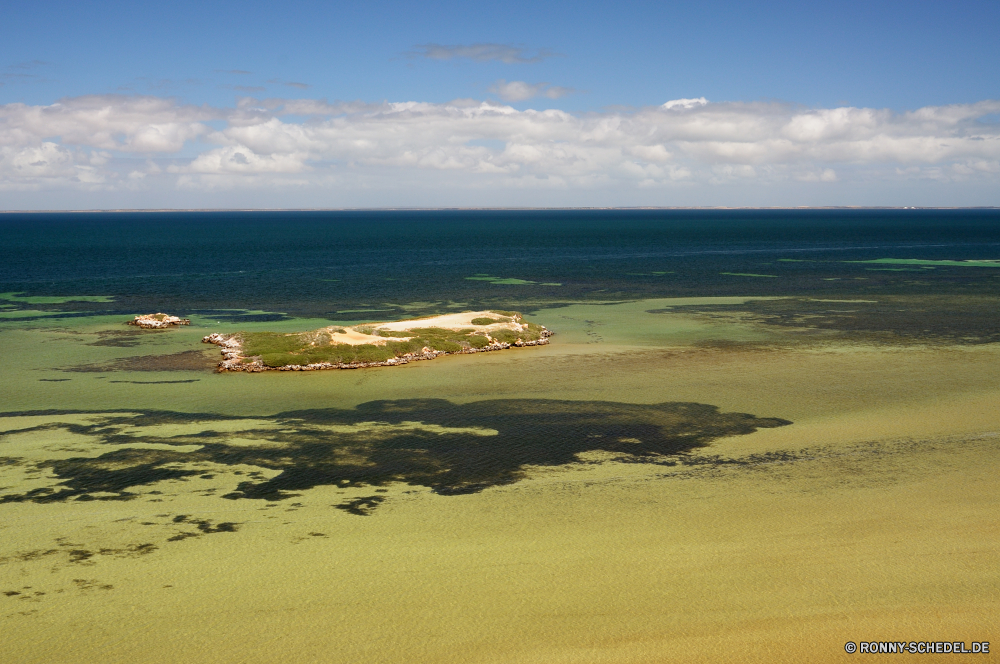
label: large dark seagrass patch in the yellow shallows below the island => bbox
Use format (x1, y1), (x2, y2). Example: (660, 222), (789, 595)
(0, 399), (791, 503)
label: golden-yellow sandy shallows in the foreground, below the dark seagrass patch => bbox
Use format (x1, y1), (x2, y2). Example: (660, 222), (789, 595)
(0, 420), (998, 664)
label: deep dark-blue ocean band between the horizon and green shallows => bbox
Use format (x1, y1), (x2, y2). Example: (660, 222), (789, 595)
(0, 210), (1000, 320)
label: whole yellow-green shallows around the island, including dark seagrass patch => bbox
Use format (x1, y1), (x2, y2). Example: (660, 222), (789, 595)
(0, 214), (1000, 662)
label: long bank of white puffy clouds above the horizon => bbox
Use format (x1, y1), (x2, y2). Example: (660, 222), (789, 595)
(0, 91), (1000, 207)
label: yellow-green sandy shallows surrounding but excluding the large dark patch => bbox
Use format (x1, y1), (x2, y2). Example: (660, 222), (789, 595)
(0, 302), (1000, 662)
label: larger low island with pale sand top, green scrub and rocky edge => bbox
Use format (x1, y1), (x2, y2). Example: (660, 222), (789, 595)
(202, 310), (552, 372)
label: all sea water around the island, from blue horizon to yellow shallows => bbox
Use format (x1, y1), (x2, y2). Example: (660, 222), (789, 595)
(0, 210), (1000, 663)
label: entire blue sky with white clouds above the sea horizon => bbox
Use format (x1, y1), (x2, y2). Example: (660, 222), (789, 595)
(0, 0), (1000, 210)
